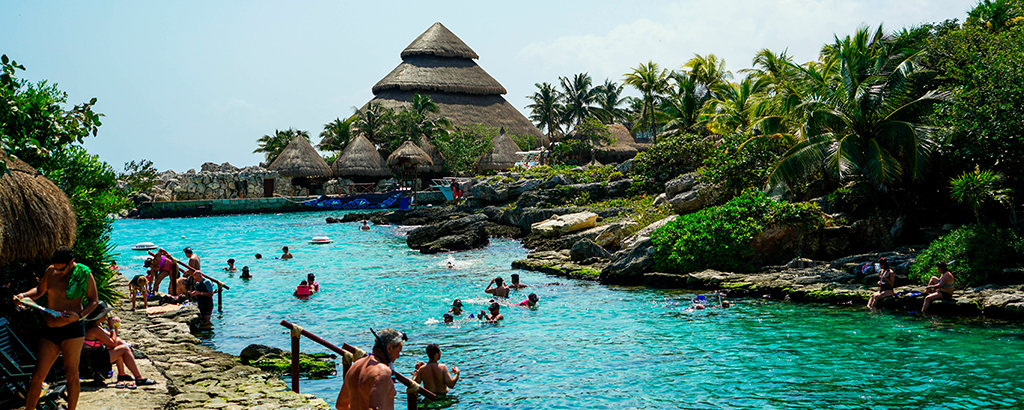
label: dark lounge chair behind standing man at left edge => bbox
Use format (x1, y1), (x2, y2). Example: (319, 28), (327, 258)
(0, 318), (66, 409)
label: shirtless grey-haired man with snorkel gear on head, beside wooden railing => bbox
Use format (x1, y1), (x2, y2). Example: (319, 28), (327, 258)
(335, 328), (408, 410)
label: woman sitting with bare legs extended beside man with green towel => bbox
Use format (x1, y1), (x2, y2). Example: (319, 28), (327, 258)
(83, 301), (157, 388)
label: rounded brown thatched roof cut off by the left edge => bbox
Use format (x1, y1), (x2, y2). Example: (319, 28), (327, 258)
(0, 152), (78, 264)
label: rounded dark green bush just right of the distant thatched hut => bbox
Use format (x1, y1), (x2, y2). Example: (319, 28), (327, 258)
(633, 134), (712, 181)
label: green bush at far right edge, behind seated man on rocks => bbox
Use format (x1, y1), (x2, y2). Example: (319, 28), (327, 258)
(910, 224), (1024, 289)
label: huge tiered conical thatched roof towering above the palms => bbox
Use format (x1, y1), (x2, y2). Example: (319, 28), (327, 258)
(370, 23), (544, 144)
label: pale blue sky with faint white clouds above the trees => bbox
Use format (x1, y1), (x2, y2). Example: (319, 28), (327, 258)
(0, 0), (978, 172)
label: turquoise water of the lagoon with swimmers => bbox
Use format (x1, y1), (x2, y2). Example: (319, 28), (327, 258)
(114, 213), (1024, 409)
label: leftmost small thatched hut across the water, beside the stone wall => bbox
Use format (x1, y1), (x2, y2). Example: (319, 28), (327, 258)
(264, 135), (331, 196)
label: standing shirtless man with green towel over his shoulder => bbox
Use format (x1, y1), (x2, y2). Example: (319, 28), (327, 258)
(14, 246), (99, 410)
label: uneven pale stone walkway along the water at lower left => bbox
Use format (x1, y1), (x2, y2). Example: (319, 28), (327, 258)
(72, 276), (329, 410)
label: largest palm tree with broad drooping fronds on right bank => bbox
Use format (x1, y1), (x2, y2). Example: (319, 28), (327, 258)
(768, 27), (941, 191)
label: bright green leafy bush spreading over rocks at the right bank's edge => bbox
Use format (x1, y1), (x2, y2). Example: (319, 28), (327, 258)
(651, 192), (821, 274)
